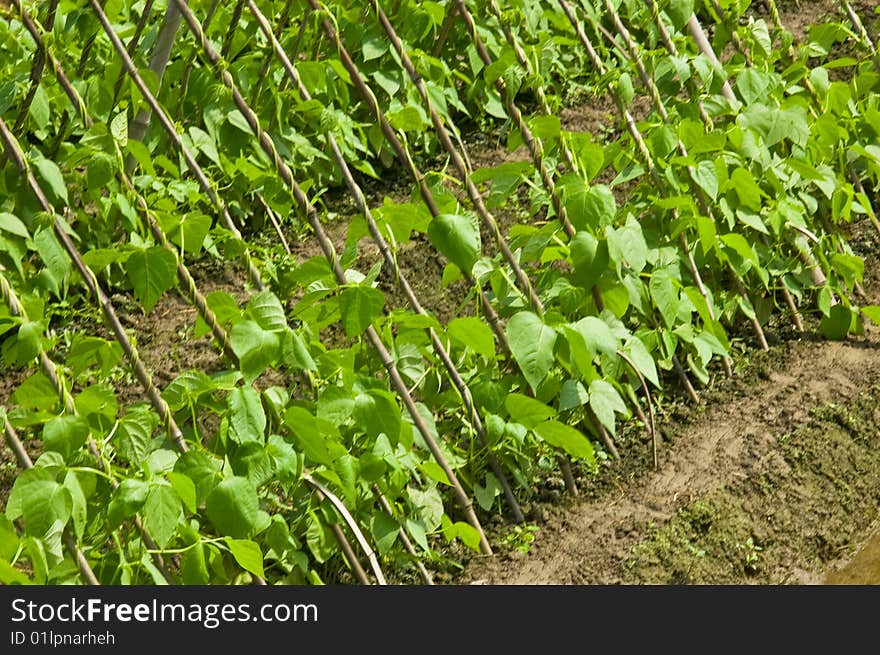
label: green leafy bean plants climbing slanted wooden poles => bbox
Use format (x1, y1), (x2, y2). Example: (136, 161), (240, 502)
(0, 0), (880, 584)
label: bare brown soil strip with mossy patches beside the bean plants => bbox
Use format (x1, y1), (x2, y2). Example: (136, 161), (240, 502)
(462, 335), (880, 584)
